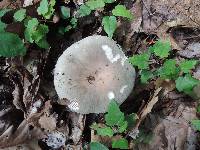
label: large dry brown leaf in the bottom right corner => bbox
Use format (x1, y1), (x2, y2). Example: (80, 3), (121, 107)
(137, 99), (198, 150)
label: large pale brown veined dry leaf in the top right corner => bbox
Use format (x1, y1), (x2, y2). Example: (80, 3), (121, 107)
(141, 0), (200, 37)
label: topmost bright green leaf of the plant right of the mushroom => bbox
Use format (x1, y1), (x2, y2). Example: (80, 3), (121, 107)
(149, 40), (171, 58)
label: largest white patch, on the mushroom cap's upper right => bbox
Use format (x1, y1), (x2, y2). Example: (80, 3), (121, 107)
(102, 45), (121, 63)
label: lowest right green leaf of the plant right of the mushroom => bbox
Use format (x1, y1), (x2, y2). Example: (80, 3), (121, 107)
(176, 74), (199, 94)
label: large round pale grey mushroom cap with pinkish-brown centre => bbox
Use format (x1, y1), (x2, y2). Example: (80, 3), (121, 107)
(54, 35), (135, 114)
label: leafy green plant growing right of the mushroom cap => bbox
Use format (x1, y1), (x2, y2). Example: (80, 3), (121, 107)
(129, 40), (200, 96)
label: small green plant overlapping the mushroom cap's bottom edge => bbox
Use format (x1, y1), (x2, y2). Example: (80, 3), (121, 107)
(91, 100), (137, 149)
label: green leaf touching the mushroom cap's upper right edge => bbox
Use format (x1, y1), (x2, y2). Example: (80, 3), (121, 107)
(129, 53), (150, 69)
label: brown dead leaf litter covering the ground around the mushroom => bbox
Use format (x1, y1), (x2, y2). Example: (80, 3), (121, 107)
(0, 0), (200, 150)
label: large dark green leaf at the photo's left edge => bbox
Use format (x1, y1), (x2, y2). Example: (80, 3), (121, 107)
(0, 32), (26, 57)
